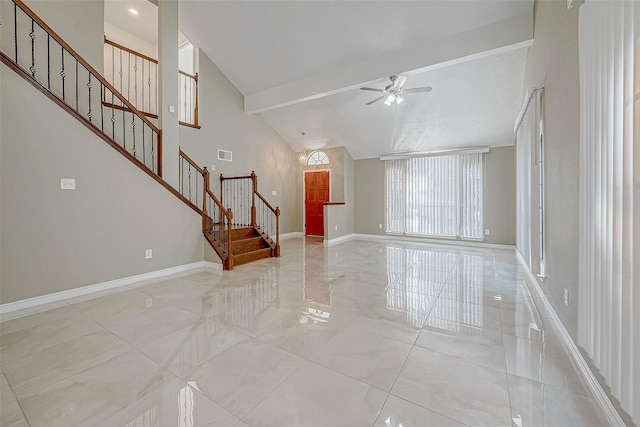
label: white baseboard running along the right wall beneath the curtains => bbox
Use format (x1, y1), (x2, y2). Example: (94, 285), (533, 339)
(515, 249), (625, 427)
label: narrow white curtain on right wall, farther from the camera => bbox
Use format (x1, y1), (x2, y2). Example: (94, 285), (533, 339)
(516, 89), (543, 273)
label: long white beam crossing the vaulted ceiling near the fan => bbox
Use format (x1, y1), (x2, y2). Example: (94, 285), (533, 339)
(244, 12), (533, 114)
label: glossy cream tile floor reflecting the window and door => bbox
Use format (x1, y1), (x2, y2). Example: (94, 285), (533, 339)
(0, 239), (607, 427)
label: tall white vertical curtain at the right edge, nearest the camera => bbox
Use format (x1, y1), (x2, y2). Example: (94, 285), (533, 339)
(578, 0), (640, 424)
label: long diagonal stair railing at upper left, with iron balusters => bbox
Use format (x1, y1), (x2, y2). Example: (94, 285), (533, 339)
(0, 0), (162, 176)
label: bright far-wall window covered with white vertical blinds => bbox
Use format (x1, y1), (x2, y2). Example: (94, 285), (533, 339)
(386, 153), (482, 239)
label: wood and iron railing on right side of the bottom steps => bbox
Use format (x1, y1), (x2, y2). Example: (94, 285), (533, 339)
(220, 171), (280, 256)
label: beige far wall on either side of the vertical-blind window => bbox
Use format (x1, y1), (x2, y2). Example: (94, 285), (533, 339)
(354, 147), (515, 245)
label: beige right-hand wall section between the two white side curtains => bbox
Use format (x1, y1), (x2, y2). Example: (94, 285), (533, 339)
(523, 0), (580, 339)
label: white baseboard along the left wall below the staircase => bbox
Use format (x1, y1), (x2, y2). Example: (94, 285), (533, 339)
(0, 261), (210, 322)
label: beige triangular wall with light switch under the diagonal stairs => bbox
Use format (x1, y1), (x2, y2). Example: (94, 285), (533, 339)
(0, 65), (203, 304)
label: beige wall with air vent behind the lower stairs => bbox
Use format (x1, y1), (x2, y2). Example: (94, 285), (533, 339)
(180, 51), (299, 233)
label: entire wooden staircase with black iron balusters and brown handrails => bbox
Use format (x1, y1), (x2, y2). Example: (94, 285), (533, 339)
(0, 0), (280, 270)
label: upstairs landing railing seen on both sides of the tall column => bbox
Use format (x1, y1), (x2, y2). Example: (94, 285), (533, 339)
(104, 37), (199, 128)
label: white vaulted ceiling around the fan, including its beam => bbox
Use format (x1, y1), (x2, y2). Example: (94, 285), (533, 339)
(105, 0), (533, 159)
